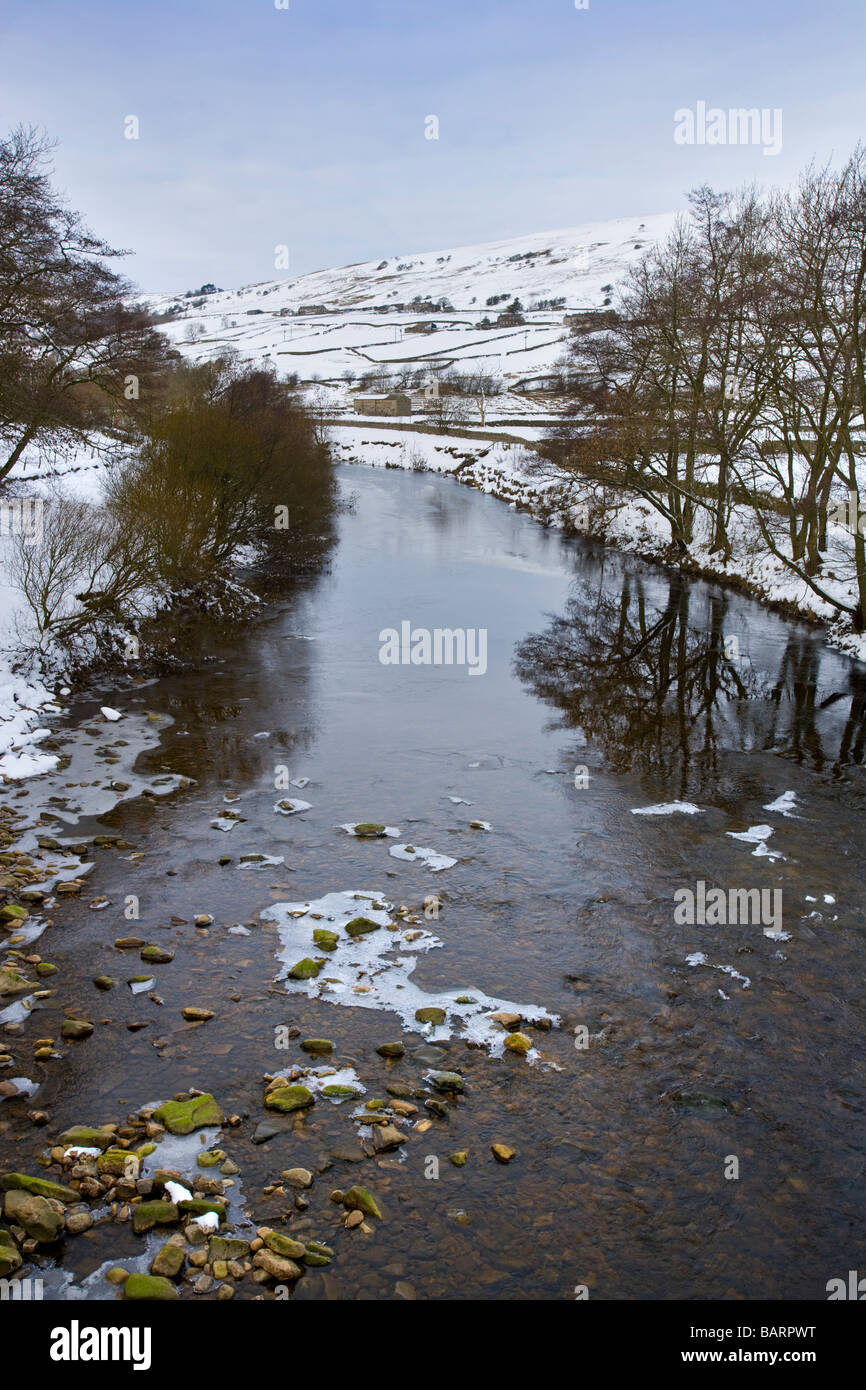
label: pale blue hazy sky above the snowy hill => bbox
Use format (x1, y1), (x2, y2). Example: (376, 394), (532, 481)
(0, 0), (866, 291)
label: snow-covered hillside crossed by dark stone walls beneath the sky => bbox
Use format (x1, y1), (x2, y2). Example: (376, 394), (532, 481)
(147, 213), (676, 389)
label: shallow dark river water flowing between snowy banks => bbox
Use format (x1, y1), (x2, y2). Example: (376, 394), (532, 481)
(0, 467), (866, 1300)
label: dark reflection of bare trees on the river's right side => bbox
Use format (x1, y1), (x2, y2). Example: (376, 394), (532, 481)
(516, 555), (866, 798)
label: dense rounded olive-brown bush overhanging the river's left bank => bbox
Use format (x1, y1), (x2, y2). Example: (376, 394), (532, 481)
(106, 359), (335, 592)
